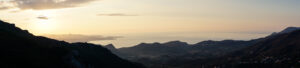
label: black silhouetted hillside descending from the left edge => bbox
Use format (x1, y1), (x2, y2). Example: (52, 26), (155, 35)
(0, 21), (144, 68)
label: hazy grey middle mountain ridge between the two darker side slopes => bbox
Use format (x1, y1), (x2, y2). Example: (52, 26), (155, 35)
(111, 39), (260, 68)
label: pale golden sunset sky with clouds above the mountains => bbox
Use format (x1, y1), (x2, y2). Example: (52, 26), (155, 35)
(0, 0), (300, 47)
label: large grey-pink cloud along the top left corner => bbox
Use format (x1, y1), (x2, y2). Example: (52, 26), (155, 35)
(0, 0), (95, 10)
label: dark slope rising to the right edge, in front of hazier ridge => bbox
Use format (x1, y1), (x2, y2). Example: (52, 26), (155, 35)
(181, 30), (300, 68)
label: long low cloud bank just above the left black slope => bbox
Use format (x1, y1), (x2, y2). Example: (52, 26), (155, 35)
(42, 34), (122, 42)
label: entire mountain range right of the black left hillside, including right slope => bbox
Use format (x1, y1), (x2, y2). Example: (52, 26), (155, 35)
(106, 27), (300, 68)
